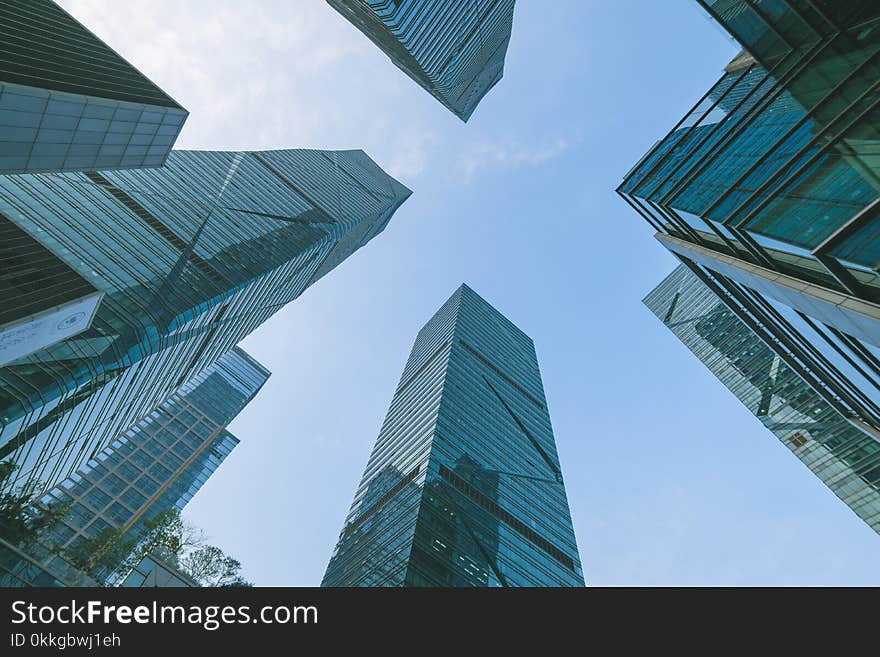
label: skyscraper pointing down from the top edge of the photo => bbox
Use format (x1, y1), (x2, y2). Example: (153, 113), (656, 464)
(327, 0), (515, 121)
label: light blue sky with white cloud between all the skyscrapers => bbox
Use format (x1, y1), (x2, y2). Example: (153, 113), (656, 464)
(61, 0), (880, 585)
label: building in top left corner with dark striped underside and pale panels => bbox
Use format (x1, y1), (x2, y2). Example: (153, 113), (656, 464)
(0, 0), (188, 174)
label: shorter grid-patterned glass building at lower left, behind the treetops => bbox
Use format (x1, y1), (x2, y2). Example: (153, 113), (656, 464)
(30, 347), (269, 584)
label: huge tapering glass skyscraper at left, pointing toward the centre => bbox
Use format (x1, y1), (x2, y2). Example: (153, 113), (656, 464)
(0, 150), (410, 492)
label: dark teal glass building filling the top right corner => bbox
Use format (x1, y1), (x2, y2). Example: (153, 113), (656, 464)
(618, 0), (880, 308)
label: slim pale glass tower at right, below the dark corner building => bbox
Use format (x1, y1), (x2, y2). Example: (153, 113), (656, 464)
(645, 265), (880, 532)
